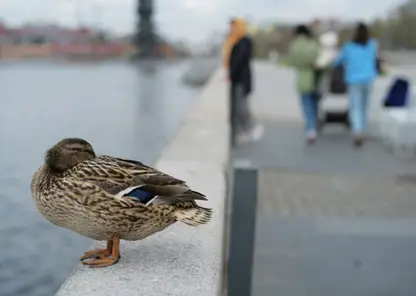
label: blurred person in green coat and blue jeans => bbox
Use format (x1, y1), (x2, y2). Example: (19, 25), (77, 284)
(280, 25), (320, 143)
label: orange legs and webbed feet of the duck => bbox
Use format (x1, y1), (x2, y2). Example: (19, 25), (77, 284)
(82, 237), (120, 268)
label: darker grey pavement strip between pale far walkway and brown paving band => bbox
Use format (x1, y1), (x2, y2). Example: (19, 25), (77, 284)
(233, 120), (416, 175)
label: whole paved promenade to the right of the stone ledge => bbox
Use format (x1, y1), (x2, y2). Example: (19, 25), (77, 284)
(233, 63), (416, 296)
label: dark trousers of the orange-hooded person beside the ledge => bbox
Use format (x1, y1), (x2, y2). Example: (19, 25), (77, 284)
(229, 83), (254, 145)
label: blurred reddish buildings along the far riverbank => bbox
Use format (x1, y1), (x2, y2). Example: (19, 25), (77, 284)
(0, 22), (187, 59)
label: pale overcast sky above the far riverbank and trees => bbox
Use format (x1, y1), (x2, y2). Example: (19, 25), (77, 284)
(0, 0), (403, 42)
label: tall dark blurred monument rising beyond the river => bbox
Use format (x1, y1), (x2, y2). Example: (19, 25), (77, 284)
(134, 0), (158, 59)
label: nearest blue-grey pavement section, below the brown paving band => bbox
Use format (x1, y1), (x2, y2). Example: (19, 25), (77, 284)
(252, 217), (416, 296)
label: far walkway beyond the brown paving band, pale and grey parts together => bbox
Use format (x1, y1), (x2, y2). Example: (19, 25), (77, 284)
(233, 63), (416, 169)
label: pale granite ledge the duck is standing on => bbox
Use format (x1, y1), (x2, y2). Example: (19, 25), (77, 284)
(57, 68), (228, 296)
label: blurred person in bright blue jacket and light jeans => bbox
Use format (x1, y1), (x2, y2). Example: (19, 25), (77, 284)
(334, 23), (378, 147)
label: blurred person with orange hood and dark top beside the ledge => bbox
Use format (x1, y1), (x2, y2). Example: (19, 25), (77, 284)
(223, 18), (263, 145)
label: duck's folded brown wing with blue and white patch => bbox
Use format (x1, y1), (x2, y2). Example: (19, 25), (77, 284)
(68, 155), (206, 204)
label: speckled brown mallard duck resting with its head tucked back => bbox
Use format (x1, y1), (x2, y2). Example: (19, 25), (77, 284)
(31, 138), (212, 267)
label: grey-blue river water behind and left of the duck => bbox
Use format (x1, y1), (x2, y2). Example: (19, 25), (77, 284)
(0, 62), (202, 296)
